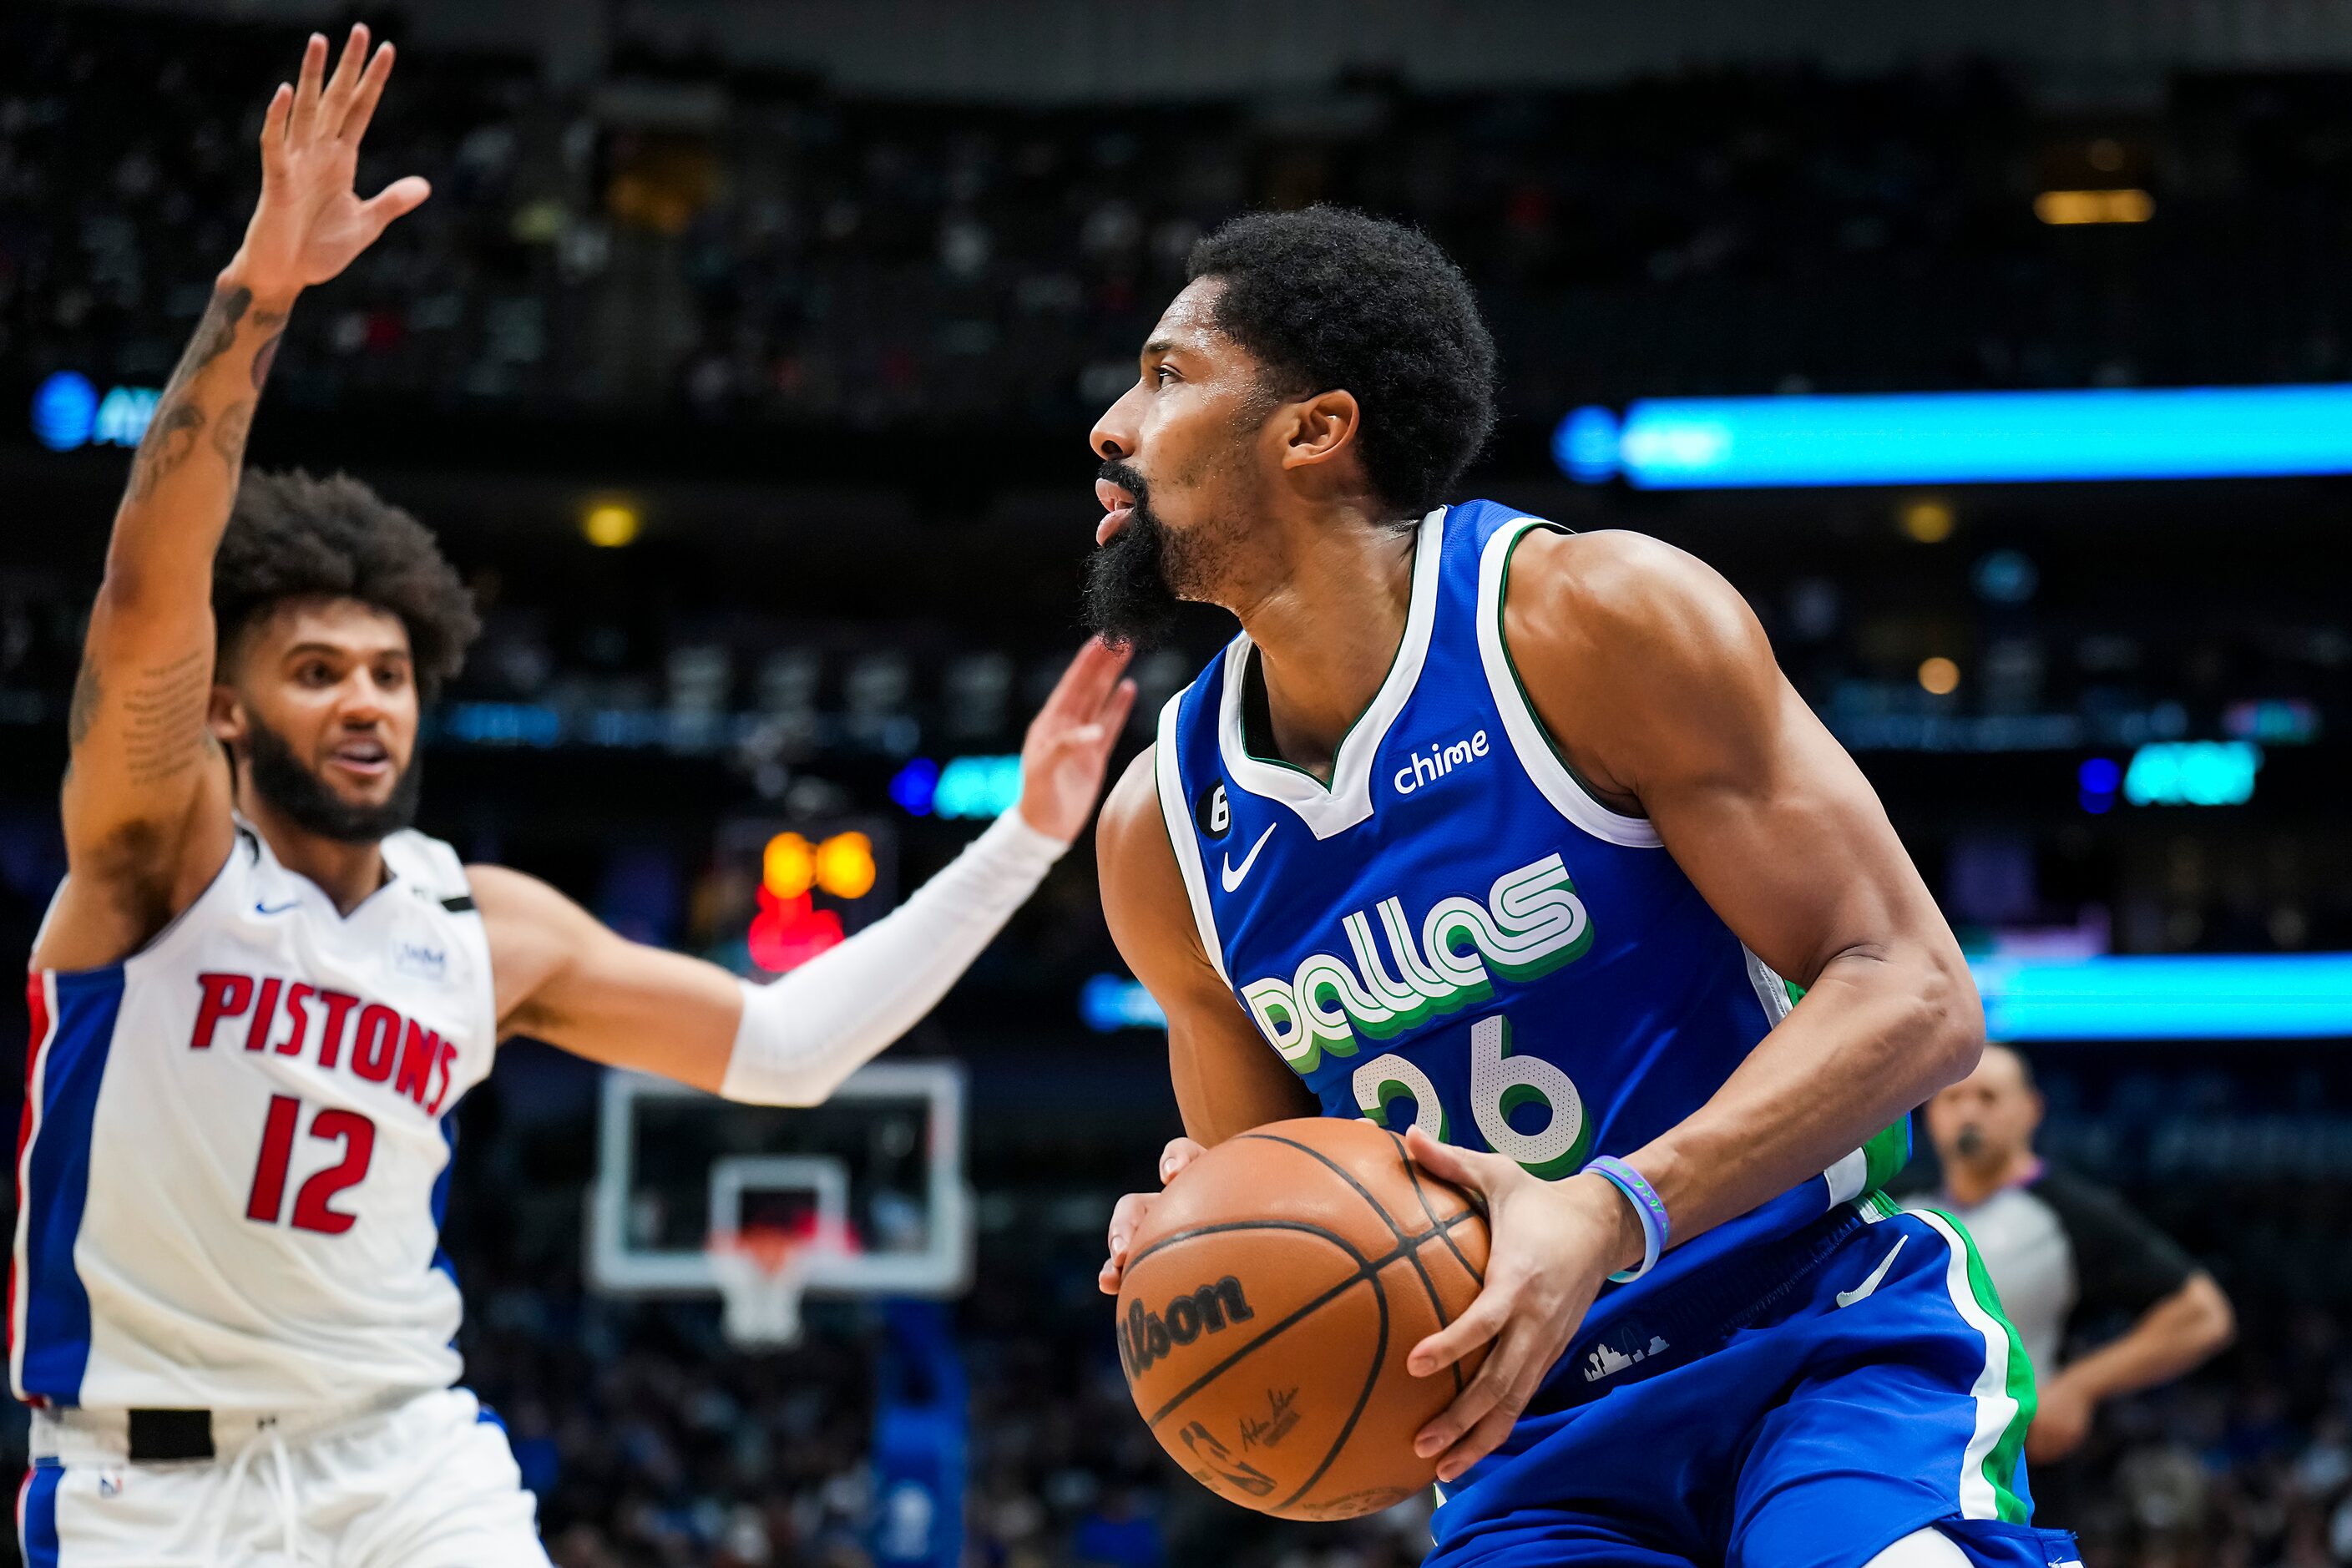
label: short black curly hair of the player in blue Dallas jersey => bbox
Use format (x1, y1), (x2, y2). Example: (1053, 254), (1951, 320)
(1186, 207), (1494, 519)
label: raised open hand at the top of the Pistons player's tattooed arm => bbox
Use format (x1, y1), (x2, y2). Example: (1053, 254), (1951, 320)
(224, 26), (432, 299)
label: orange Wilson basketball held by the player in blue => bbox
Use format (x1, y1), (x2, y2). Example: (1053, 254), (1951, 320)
(1117, 1116), (1486, 1519)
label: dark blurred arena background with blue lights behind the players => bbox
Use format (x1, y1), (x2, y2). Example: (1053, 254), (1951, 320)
(0, 0), (2352, 1568)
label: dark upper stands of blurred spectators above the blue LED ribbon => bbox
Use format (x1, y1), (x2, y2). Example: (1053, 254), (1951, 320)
(0, 0), (2352, 427)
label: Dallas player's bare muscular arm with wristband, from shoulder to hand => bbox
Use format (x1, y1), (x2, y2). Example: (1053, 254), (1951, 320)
(1411, 531), (1985, 1479)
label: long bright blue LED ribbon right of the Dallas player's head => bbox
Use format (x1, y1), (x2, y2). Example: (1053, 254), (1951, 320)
(1552, 386), (2352, 489)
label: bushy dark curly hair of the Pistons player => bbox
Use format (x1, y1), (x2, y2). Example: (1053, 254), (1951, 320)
(212, 468), (482, 701)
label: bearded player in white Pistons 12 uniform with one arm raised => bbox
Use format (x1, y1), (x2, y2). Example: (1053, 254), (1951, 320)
(9, 28), (1134, 1568)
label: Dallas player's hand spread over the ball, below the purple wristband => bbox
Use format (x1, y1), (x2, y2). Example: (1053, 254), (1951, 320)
(1404, 1126), (1641, 1481)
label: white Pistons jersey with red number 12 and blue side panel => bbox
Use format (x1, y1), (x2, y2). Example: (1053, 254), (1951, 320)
(9, 822), (498, 1410)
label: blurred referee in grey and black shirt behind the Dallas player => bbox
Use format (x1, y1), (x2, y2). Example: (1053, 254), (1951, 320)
(1917, 1044), (2237, 1462)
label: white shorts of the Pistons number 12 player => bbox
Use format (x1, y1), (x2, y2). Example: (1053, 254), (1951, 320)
(17, 1389), (548, 1568)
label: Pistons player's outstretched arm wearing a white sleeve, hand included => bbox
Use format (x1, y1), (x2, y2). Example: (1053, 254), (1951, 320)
(468, 642), (1136, 1105)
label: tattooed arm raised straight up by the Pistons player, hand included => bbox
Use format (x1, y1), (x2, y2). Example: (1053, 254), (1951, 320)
(35, 28), (428, 969)
